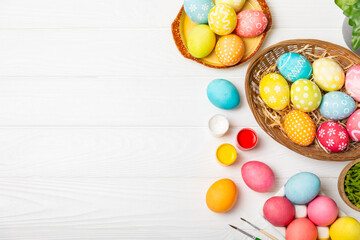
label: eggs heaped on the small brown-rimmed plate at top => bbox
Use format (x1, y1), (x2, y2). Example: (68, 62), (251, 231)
(184, 0), (268, 66)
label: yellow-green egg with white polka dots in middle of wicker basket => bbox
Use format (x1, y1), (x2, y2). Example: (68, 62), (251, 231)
(290, 79), (322, 112)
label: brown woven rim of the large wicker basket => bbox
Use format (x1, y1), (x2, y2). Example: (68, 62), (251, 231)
(245, 39), (360, 161)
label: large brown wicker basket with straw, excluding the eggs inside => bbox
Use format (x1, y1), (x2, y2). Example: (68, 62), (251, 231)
(245, 39), (360, 161)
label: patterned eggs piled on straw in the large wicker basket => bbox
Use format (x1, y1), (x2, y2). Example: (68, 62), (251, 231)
(259, 52), (360, 152)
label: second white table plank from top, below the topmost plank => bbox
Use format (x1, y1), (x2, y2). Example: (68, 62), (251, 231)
(0, 27), (345, 77)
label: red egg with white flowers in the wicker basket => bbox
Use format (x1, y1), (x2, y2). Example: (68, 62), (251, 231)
(317, 122), (349, 152)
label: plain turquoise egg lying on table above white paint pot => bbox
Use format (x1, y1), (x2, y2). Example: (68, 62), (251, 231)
(207, 79), (240, 109)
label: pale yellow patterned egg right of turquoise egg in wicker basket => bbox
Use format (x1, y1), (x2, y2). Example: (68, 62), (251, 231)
(313, 58), (345, 92)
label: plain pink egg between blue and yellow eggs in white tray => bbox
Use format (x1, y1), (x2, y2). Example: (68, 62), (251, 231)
(308, 196), (339, 227)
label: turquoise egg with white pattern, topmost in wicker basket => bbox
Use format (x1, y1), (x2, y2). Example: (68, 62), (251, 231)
(277, 53), (312, 82)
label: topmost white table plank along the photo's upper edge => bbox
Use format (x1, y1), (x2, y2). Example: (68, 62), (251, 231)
(0, 0), (344, 29)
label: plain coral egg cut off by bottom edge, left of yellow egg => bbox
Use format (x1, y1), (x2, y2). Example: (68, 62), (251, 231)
(286, 218), (317, 240)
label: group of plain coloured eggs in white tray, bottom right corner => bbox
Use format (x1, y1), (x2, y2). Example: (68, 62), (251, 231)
(263, 172), (360, 240)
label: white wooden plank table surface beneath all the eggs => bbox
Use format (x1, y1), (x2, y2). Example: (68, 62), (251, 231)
(0, 0), (359, 240)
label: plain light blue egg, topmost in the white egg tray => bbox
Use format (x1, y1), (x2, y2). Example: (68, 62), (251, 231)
(285, 172), (320, 204)
